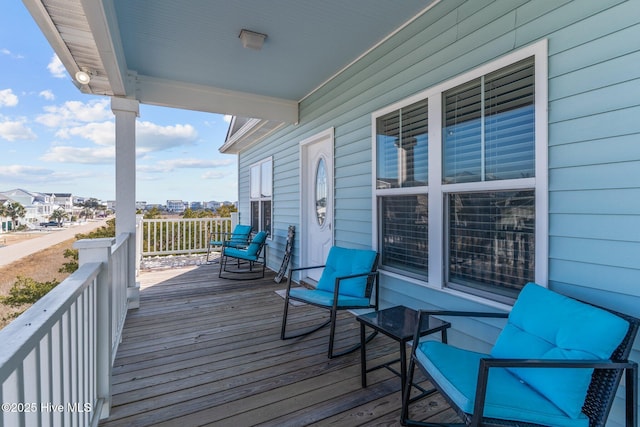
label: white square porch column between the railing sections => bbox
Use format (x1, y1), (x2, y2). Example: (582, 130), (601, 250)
(111, 97), (140, 308)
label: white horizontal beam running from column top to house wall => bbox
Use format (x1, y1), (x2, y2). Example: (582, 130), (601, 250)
(136, 74), (298, 123)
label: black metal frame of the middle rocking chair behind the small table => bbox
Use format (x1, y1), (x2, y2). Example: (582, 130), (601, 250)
(280, 255), (380, 359)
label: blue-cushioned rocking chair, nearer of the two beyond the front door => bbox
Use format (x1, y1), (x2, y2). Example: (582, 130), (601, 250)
(218, 231), (269, 280)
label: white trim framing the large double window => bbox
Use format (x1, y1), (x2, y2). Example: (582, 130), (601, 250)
(371, 39), (549, 308)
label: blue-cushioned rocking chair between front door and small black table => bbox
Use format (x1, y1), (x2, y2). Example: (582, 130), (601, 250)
(280, 246), (378, 358)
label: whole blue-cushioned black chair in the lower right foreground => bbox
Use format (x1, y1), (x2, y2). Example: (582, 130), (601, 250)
(401, 283), (640, 427)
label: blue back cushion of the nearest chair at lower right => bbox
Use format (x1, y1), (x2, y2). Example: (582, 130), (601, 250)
(491, 283), (629, 418)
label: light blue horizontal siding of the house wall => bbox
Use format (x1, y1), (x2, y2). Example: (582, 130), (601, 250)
(239, 0), (640, 425)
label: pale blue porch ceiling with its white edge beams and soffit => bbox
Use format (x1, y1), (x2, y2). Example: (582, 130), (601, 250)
(23, 0), (434, 123)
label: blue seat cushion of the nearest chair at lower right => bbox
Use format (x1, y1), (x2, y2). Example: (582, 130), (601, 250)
(416, 341), (589, 427)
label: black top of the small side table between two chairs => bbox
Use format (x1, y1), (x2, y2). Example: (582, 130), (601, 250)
(356, 305), (451, 341)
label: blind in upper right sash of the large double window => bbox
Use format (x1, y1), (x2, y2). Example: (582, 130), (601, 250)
(443, 58), (535, 184)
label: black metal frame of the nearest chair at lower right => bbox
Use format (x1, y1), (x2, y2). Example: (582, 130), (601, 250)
(400, 303), (640, 427)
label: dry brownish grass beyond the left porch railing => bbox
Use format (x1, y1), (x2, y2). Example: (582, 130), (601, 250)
(0, 238), (76, 328)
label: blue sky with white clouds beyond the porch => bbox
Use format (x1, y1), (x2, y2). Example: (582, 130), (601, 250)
(0, 0), (238, 204)
